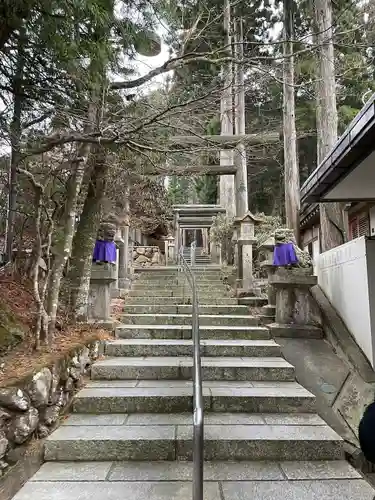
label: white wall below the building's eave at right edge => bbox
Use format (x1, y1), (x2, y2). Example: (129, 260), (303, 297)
(316, 236), (375, 367)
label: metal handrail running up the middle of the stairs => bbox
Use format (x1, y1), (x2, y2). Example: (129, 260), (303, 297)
(178, 247), (204, 500)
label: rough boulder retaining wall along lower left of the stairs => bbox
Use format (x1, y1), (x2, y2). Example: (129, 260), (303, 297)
(0, 341), (102, 476)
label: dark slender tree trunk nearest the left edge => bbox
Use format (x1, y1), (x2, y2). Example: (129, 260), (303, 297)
(5, 28), (25, 262)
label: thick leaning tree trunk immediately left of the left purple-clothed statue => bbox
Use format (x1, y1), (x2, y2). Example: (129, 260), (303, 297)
(68, 145), (109, 320)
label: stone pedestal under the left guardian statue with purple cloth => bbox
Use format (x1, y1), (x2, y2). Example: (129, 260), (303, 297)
(88, 264), (117, 322)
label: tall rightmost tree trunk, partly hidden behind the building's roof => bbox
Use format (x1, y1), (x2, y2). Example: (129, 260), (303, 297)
(314, 0), (346, 252)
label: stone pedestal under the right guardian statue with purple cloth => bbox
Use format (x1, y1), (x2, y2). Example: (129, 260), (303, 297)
(269, 267), (322, 337)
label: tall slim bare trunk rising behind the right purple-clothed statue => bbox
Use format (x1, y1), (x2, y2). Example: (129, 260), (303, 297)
(283, 0), (300, 243)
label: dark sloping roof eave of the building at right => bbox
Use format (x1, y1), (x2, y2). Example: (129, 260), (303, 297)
(301, 94), (375, 204)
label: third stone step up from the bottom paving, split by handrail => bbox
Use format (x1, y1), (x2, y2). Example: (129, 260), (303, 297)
(91, 356), (294, 381)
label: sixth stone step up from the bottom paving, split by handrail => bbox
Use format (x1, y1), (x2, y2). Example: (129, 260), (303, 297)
(121, 313), (259, 326)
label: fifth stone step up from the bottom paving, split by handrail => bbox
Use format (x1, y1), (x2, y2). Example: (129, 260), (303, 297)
(115, 325), (270, 340)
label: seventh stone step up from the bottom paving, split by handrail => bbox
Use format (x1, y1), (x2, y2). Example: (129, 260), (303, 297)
(124, 304), (249, 316)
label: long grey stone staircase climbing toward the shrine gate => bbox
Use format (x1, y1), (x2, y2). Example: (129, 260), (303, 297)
(15, 266), (375, 500)
